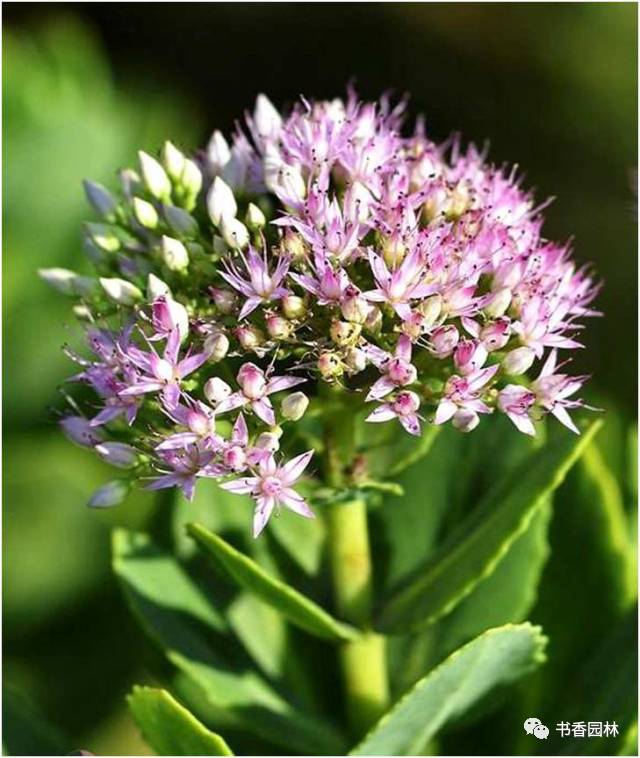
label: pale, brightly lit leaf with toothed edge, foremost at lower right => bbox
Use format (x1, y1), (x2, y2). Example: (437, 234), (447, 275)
(351, 624), (546, 755)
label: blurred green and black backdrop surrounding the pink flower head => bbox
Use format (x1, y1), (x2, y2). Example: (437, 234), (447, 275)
(3, 3), (637, 754)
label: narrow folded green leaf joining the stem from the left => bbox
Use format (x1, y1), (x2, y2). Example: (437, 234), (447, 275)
(187, 524), (358, 642)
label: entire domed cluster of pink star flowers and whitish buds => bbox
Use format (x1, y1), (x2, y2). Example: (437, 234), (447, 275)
(41, 93), (597, 534)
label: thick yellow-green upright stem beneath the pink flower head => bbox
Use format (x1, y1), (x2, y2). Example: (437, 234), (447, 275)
(325, 394), (389, 739)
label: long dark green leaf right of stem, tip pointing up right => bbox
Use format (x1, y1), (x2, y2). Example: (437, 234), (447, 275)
(377, 422), (600, 633)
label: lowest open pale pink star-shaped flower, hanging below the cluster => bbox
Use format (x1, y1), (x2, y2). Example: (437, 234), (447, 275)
(220, 450), (314, 537)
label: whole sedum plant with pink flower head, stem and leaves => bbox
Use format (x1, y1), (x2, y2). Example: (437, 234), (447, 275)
(41, 93), (620, 755)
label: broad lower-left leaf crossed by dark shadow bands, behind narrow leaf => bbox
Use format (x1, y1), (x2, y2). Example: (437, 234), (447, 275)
(113, 530), (343, 754)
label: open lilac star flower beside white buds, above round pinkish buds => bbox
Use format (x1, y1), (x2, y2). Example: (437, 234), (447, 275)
(220, 246), (290, 319)
